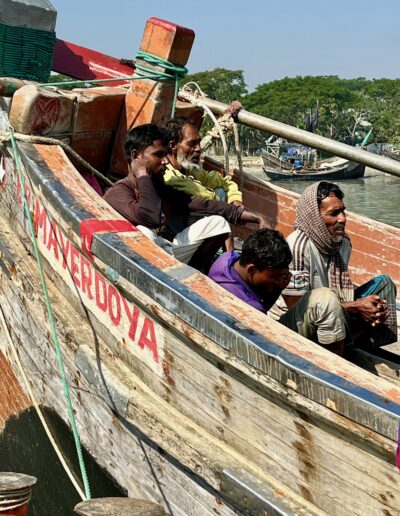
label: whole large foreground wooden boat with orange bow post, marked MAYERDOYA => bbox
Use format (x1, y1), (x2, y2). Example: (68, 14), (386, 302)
(0, 9), (400, 515)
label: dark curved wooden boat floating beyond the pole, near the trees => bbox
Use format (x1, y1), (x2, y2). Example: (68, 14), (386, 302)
(261, 147), (365, 181)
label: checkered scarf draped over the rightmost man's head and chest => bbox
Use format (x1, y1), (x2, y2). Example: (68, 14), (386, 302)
(293, 182), (354, 302)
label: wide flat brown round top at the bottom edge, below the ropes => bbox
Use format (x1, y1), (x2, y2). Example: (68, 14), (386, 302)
(75, 497), (167, 516)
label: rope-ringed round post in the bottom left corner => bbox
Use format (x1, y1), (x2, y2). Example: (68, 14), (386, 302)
(0, 472), (37, 516)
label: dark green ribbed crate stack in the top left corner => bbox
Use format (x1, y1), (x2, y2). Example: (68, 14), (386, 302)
(0, 23), (56, 82)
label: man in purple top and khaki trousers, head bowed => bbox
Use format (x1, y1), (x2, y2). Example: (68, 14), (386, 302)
(209, 229), (345, 354)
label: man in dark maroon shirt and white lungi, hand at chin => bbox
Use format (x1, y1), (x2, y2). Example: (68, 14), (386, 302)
(104, 124), (263, 272)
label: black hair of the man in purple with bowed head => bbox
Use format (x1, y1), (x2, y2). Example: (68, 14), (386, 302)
(239, 229), (292, 271)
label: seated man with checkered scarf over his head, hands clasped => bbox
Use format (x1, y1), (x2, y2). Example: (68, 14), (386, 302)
(283, 181), (397, 346)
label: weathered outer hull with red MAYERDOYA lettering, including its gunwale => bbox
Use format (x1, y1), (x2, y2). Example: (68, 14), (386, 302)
(0, 134), (400, 514)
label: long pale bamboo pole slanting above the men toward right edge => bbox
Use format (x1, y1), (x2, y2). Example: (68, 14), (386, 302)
(179, 90), (400, 177)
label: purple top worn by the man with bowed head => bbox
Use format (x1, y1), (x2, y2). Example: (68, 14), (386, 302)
(208, 251), (279, 313)
